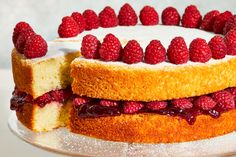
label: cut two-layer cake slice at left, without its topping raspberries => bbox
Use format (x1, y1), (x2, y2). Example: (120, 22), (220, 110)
(11, 37), (80, 132)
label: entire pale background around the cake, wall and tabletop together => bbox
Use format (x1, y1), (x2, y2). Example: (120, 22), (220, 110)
(0, 0), (236, 157)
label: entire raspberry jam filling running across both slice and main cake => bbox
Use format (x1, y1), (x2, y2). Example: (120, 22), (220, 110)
(10, 87), (236, 125)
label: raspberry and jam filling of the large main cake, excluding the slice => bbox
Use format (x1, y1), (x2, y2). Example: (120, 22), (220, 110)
(73, 87), (236, 125)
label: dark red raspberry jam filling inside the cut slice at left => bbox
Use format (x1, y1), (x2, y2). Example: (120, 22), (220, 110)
(10, 87), (72, 112)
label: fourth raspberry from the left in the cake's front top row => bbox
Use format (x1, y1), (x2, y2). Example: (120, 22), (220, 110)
(144, 40), (166, 64)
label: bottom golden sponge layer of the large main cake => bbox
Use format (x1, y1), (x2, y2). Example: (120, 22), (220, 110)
(69, 109), (236, 143)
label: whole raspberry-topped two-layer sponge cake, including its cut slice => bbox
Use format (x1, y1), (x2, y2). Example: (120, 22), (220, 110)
(11, 4), (236, 143)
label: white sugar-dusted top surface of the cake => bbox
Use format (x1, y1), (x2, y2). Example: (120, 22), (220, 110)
(33, 25), (234, 68)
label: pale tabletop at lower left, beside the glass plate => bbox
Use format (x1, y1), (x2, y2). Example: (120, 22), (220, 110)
(0, 69), (62, 157)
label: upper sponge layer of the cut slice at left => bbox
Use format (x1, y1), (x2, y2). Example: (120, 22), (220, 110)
(11, 49), (80, 98)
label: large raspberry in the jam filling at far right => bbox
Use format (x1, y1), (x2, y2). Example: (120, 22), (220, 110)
(212, 90), (235, 109)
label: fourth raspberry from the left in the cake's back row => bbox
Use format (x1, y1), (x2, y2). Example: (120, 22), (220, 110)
(98, 6), (118, 28)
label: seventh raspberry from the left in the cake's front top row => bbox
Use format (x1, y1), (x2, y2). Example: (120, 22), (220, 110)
(208, 36), (227, 59)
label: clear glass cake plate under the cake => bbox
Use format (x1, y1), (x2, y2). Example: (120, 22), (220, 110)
(8, 113), (236, 157)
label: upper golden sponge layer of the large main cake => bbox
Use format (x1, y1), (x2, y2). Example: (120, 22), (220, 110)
(71, 58), (236, 101)
